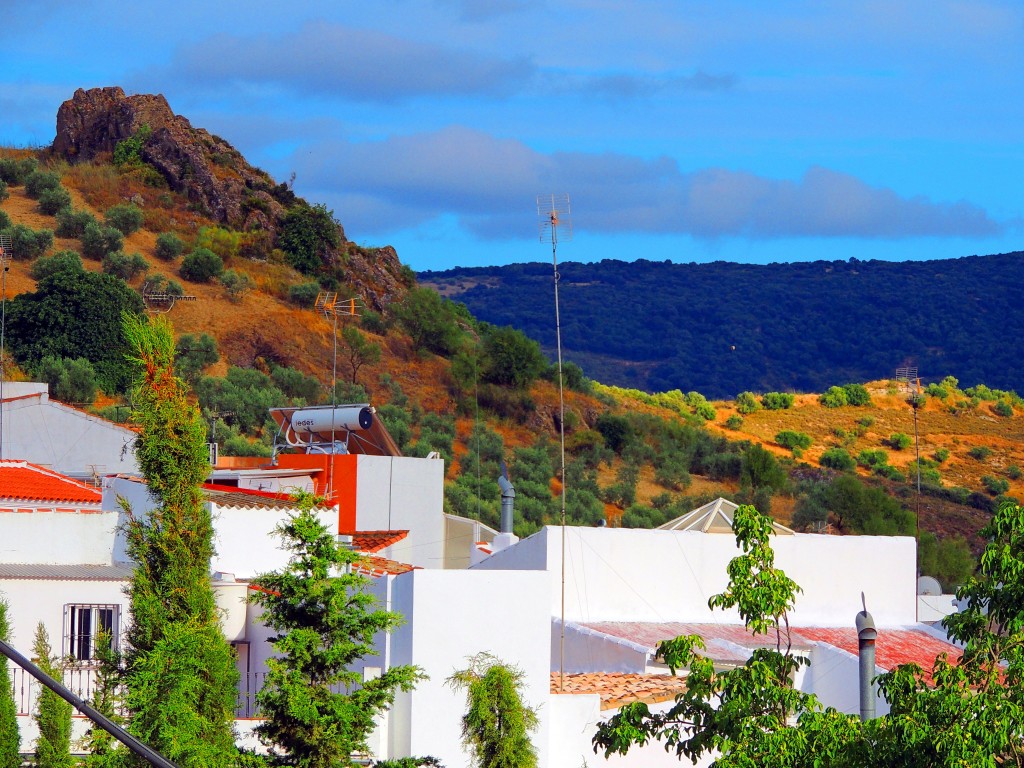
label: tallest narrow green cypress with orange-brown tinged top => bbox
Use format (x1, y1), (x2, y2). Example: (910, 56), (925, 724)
(124, 315), (239, 768)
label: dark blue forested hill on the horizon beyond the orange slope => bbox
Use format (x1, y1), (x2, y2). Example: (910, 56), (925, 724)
(418, 257), (1024, 397)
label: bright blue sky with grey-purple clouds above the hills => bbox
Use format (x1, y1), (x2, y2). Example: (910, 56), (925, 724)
(0, 0), (1024, 270)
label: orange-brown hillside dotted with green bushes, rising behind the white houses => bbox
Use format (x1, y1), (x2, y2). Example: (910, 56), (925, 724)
(0, 88), (1024, 581)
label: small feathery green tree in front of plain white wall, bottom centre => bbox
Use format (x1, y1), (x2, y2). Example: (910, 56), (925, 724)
(445, 653), (539, 768)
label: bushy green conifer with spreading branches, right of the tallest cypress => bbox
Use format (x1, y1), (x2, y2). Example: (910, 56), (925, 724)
(253, 495), (423, 768)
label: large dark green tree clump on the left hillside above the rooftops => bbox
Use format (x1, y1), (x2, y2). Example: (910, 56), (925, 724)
(7, 269), (143, 393)
